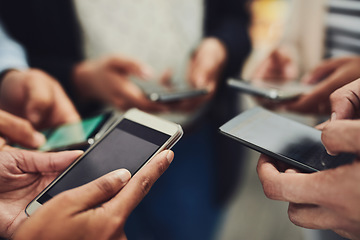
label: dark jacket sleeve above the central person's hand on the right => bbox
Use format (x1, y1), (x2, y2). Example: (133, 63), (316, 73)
(204, 0), (251, 76)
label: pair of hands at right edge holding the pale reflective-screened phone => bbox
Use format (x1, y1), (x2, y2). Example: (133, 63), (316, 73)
(257, 79), (360, 239)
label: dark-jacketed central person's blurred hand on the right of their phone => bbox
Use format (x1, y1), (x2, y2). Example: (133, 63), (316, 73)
(172, 38), (227, 112)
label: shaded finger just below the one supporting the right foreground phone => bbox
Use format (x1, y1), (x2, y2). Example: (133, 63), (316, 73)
(288, 203), (342, 229)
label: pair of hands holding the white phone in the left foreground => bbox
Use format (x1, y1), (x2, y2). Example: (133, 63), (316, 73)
(0, 147), (174, 240)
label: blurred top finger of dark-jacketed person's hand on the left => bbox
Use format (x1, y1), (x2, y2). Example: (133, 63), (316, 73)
(108, 56), (154, 79)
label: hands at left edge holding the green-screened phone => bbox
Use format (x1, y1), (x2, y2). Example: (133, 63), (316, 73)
(0, 69), (80, 148)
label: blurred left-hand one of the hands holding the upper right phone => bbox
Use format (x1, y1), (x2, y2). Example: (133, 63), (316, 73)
(252, 47), (299, 83)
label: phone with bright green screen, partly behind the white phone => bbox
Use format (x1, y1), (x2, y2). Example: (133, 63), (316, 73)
(38, 112), (115, 151)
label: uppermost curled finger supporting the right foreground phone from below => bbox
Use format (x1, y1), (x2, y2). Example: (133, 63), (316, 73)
(257, 155), (330, 204)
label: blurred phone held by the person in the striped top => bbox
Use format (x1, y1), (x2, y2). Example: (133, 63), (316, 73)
(226, 78), (312, 101)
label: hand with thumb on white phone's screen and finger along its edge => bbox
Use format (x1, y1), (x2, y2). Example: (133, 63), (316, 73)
(14, 151), (174, 240)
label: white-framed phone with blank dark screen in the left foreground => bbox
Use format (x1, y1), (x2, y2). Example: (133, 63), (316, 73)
(25, 109), (183, 216)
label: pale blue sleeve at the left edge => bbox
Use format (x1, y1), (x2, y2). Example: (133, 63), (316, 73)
(0, 21), (28, 73)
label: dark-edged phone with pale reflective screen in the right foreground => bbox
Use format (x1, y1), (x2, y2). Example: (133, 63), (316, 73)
(220, 107), (356, 172)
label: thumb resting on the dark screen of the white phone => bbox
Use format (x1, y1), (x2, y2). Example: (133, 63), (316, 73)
(57, 169), (131, 212)
